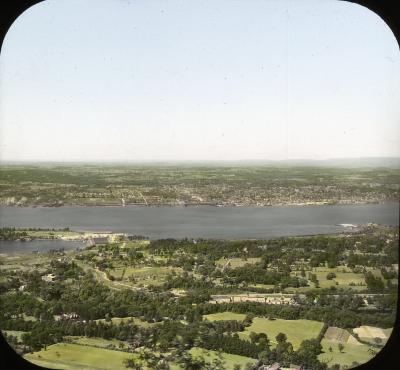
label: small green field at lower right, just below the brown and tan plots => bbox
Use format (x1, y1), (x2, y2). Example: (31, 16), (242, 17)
(318, 339), (376, 366)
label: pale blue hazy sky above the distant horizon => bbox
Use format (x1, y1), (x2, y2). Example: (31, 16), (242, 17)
(0, 0), (400, 161)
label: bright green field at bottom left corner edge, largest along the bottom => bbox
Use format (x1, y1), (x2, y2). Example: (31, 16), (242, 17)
(24, 343), (134, 370)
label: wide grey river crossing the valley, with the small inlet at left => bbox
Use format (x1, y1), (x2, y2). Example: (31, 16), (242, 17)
(0, 202), (399, 252)
